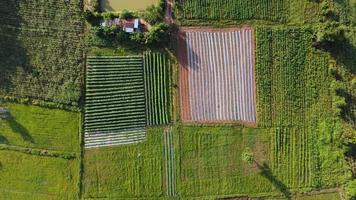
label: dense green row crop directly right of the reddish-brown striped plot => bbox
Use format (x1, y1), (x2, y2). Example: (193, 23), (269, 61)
(256, 28), (327, 127)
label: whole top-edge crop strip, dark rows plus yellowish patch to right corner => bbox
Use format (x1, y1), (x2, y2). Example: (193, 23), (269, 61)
(175, 0), (356, 26)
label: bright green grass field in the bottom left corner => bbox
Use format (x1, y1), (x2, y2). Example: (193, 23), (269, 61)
(0, 151), (79, 200)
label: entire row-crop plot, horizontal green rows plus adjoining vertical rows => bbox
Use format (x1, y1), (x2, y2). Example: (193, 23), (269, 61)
(84, 52), (170, 147)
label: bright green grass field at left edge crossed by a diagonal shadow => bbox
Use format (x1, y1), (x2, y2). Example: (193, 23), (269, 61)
(0, 103), (79, 152)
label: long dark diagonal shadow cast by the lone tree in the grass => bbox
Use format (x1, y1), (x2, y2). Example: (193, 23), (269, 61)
(255, 161), (292, 199)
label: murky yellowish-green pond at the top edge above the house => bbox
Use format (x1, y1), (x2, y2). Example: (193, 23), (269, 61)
(100, 0), (158, 11)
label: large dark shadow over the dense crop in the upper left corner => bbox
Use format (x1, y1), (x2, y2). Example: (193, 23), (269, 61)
(0, 1), (32, 95)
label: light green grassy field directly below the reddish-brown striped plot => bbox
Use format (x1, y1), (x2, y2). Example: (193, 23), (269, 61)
(175, 126), (273, 197)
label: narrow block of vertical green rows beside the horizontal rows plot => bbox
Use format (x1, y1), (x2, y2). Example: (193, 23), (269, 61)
(144, 53), (171, 125)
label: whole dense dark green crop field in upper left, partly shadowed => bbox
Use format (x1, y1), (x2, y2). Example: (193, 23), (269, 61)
(0, 0), (84, 105)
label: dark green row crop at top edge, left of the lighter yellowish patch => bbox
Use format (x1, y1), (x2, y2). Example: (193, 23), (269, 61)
(177, 0), (288, 21)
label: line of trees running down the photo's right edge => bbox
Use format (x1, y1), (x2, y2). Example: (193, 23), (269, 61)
(313, 0), (356, 200)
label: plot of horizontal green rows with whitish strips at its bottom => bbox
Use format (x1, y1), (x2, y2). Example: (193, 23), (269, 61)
(84, 56), (146, 148)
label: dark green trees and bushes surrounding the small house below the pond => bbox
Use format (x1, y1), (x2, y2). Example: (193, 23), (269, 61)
(85, 0), (176, 47)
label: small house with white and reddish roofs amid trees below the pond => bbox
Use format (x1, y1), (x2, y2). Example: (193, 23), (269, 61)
(100, 18), (142, 33)
